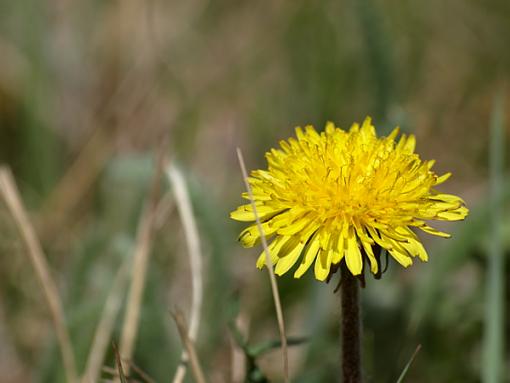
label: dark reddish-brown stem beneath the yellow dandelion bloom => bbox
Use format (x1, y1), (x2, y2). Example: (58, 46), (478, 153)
(341, 263), (362, 383)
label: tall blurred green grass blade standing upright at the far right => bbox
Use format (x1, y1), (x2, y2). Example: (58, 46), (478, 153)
(482, 92), (505, 383)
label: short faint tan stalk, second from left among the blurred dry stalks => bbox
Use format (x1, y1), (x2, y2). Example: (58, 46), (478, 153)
(81, 258), (130, 383)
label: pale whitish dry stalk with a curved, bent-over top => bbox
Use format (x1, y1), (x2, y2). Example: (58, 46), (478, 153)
(166, 165), (203, 383)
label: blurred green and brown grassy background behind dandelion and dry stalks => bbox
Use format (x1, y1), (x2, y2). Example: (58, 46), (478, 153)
(0, 0), (510, 383)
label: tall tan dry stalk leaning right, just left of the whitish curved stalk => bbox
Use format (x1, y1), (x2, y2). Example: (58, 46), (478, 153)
(116, 140), (166, 373)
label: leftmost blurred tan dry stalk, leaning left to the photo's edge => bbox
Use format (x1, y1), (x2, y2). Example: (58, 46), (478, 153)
(0, 167), (78, 383)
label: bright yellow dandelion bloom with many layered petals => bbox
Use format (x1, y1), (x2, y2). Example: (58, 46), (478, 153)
(230, 118), (468, 281)
